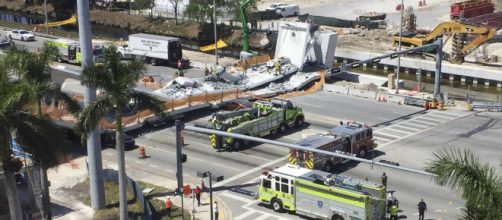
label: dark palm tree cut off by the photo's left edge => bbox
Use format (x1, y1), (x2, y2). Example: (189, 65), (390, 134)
(0, 49), (72, 219)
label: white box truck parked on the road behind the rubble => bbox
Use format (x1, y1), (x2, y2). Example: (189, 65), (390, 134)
(118, 34), (190, 68)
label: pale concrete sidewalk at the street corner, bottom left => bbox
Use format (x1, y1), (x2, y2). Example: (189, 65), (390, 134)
(48, 157), (232, 220)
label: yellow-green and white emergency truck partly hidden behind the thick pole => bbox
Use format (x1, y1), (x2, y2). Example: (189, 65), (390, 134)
(47, 39), (103, 64)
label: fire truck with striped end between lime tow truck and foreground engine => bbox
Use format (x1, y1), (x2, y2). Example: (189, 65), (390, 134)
(288, 122), (376, 172)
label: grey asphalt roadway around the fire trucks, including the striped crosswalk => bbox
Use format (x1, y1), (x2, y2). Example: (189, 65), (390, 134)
(2, 28), (494, 219)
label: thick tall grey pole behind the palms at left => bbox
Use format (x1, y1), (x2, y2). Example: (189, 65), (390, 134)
(77, 0), (105, 209)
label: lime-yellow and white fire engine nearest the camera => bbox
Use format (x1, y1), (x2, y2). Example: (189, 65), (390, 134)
(258, 165), (387, 220)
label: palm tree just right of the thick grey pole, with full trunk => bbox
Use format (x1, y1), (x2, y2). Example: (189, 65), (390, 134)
(76, 47), (161, 220)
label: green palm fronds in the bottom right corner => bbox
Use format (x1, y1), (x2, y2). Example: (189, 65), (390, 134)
(426, 149), (502, 220)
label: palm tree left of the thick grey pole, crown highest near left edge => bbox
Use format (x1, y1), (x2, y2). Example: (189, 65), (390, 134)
(7, 44), (80, 219)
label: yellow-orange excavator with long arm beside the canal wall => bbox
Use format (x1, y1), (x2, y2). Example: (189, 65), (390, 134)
(392, 21), (497, 64)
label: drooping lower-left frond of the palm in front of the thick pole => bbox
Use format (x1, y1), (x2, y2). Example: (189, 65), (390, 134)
(75, 95), (115, 139)
